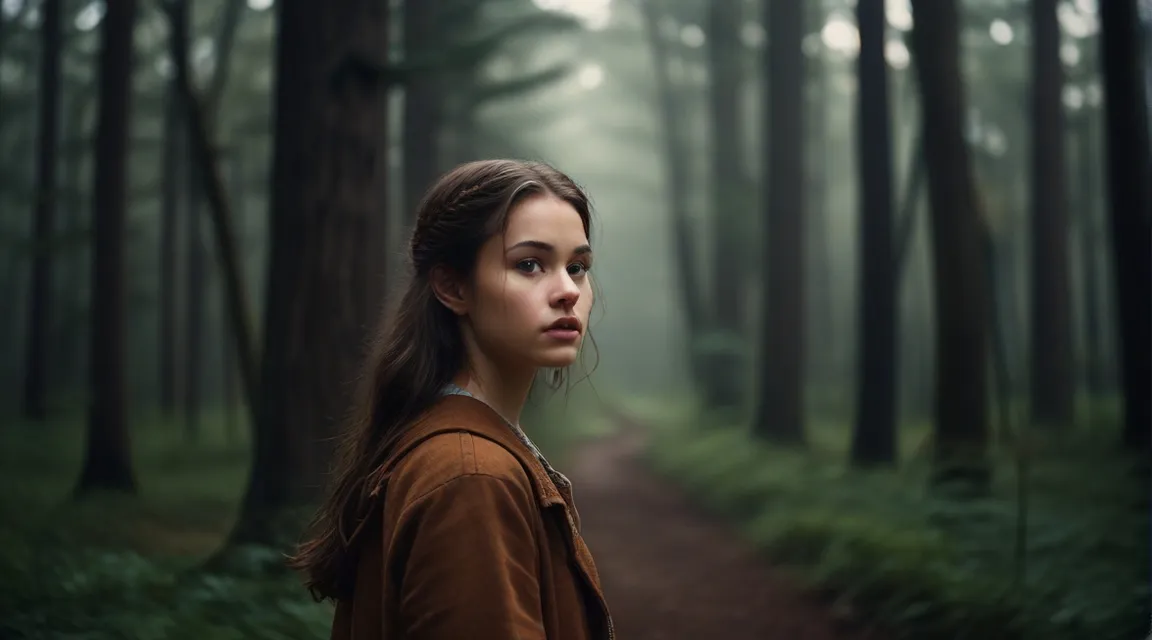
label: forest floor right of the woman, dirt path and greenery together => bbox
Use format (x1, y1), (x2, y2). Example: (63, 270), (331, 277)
(585, 398), (1152, 640)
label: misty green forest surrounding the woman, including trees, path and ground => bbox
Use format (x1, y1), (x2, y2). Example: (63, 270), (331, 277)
(0, 0), (1152, 640)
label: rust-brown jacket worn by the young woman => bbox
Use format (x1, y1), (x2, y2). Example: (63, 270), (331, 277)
(332, 396), (614, 640)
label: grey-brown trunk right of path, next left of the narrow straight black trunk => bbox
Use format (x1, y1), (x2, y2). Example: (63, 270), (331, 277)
(753, 0), (806, 443)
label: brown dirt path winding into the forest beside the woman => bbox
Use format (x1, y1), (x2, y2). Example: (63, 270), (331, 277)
(566, 429), (877, 640)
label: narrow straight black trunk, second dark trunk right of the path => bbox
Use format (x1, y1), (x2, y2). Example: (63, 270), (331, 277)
(851, 0), (899, 465)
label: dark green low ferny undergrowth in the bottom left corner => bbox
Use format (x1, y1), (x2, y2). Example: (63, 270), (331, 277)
(0, 547), (332, 640)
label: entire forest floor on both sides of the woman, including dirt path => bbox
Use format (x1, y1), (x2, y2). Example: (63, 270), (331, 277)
(0, 396), (1152, 640)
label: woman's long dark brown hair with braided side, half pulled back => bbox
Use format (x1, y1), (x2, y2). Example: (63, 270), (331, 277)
(289, 160), (591, 600)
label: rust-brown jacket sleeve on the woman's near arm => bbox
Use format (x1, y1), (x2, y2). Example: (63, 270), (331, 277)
(393, 473), (545, 640)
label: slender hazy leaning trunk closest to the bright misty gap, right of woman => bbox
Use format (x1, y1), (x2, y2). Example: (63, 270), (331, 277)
(641, 0), (705, 388)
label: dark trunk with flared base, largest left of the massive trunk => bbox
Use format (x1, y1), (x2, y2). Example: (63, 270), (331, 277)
(76, 0), (136, 493)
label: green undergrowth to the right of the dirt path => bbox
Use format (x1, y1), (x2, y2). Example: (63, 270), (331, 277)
(632, 403), (1152, 640)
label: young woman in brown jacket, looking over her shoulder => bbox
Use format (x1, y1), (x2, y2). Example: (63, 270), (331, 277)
(293, 160), (614, 640)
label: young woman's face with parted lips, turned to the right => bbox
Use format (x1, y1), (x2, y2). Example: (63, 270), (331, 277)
(465, 193), (592, 368)
